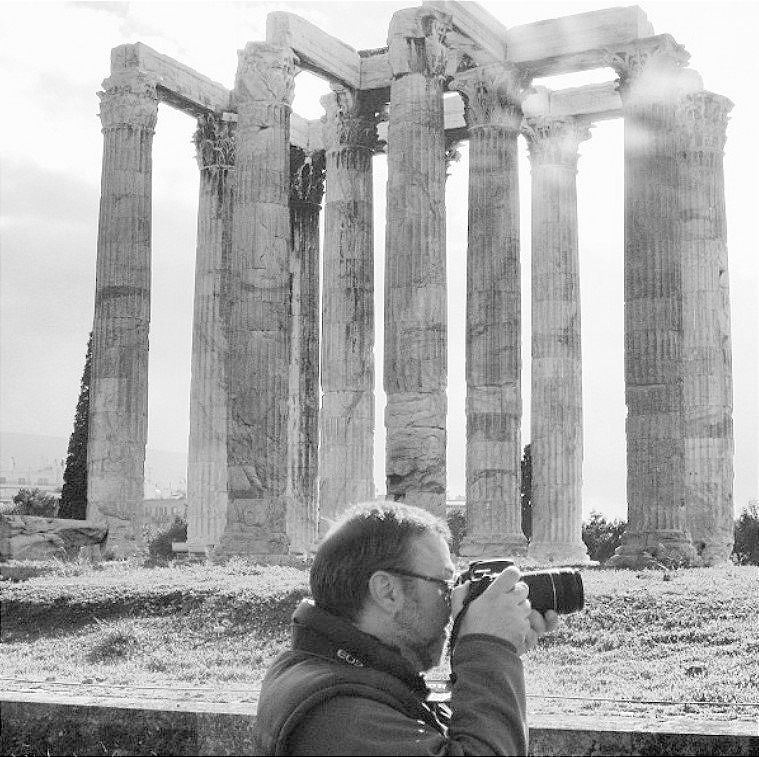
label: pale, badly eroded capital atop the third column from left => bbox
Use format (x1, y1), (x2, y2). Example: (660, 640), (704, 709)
(235, 42), (295, 107)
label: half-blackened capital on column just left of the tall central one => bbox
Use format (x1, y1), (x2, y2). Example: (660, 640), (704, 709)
(321, 87), (378, 150)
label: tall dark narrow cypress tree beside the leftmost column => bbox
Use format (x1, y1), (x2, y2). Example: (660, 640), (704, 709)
(58, 332), (92, 520)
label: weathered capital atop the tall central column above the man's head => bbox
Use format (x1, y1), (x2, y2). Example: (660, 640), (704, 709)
(387, 7), (452, 78)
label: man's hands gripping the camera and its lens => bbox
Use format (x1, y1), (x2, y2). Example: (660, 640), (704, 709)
(451, 565), (558, 655)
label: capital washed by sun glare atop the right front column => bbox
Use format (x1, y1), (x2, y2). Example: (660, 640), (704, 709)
(605, 34), (695, 100)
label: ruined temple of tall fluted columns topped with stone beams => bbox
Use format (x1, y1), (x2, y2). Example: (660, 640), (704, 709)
(87, 2), (733, 566)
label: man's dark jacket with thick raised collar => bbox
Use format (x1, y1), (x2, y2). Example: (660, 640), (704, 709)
(254, 600), (527, 755)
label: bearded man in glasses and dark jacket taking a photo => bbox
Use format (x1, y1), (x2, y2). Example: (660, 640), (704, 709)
(255, 502), (558, 755)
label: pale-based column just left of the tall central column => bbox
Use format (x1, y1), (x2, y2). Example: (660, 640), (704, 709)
(319, 88), (377, 533)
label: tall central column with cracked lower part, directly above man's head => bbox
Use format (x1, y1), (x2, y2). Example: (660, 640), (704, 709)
(384, 9), (447, 516)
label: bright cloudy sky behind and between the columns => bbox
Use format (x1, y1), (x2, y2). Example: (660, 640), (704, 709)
(0, 1), (759, 517)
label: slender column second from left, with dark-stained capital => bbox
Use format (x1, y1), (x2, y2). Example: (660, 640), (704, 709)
(187, 113), (234, 552)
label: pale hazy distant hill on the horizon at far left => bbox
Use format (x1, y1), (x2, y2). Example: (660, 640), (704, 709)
(0, 432), (187, 497)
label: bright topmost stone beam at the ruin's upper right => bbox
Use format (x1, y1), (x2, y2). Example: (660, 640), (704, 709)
(505, 5), (654, 76)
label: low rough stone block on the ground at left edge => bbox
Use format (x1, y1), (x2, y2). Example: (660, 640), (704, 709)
(0, 515), (108, 560)
